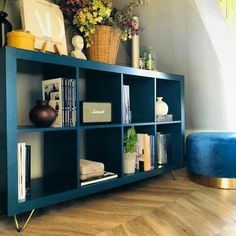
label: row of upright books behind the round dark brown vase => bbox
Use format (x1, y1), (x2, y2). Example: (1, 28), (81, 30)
(42, 78), (77, 127)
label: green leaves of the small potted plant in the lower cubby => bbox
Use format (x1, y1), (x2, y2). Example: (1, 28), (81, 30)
(124, 126), (138, 153)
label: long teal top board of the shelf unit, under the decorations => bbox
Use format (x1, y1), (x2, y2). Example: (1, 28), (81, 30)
(0, 47), (184, 81)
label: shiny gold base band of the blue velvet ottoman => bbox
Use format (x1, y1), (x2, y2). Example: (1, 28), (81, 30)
(189, 172), (236, 189)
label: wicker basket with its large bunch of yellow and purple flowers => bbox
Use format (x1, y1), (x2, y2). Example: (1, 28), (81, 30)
(48, 0), (147, 64)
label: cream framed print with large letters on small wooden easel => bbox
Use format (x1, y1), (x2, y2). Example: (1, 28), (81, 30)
(20, 0), (68, 55)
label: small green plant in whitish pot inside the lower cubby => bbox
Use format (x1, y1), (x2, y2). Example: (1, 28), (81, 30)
(124, 127), (138, 174)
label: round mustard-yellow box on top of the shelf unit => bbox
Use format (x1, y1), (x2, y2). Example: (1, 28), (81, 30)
(7, 30), (35, 51)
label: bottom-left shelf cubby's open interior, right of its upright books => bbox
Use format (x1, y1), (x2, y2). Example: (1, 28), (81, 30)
(17, 131), (78, 199)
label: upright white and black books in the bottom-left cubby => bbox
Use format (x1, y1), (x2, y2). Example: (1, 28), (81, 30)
(17, 143), (31, 201)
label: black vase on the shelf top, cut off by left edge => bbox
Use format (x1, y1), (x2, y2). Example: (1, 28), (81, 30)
(0, 11), (12, 47)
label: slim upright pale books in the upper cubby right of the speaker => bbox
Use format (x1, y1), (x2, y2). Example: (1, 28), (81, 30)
(123, 85), (131, 124)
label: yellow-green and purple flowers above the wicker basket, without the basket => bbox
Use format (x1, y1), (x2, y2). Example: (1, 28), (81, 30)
(48, 0), (149, 47)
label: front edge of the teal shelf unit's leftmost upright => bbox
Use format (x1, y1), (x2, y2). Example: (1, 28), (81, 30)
(5, 49), (18, 215)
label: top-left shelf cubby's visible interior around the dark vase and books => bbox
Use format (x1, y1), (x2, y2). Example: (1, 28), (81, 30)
(16, 59), (76, 127)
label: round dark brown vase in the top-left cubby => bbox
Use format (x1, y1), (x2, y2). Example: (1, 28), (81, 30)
(29, 100), (57, 128)
